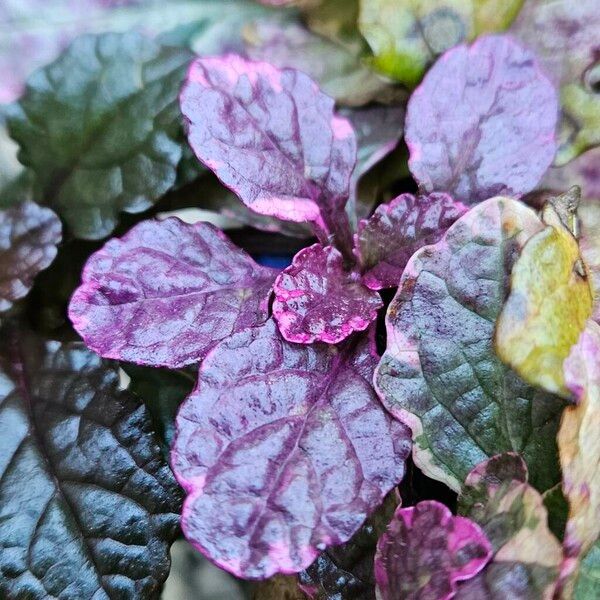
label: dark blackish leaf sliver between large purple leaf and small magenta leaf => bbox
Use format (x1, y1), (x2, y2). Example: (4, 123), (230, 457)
(298, 491), (400, 600)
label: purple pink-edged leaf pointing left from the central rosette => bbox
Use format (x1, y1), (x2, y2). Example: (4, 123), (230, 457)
(69, 218), (277, 368)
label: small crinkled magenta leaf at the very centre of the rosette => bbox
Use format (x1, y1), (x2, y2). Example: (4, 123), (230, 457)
(273, 244), (383, 344)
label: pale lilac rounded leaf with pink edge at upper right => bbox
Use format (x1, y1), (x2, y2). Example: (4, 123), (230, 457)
(406, 35), (558, 204)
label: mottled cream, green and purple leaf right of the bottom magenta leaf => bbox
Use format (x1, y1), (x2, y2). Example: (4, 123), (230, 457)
(456, 453), (562, 600)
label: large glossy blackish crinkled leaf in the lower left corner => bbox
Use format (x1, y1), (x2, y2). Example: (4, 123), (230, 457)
(0, 331), (181, 600)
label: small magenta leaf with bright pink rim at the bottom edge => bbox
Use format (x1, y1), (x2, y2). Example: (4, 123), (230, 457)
(375, 500), (492, 600)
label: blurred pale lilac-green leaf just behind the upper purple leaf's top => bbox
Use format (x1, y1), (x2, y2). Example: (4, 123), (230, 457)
(245, 21), (393, 106)
